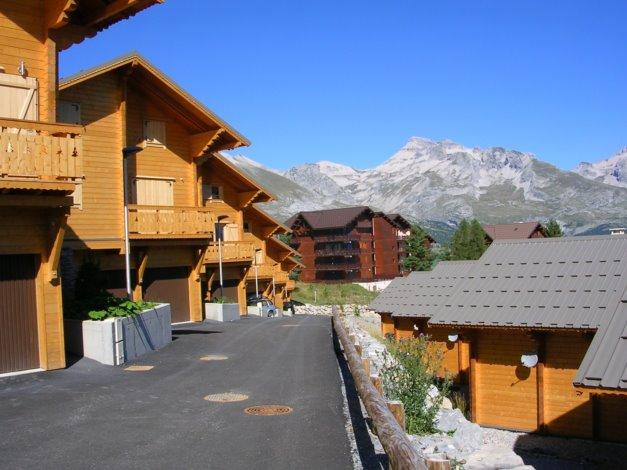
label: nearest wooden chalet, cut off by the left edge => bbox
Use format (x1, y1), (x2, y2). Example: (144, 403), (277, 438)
(0, 0), (160, 373)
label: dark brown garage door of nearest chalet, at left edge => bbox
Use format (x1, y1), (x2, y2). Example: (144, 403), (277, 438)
(0, 255), (39, 373)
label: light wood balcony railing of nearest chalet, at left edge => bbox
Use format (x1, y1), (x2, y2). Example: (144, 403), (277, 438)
(0, 118), (84, 181)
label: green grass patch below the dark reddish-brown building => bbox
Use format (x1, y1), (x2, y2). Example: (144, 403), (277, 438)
(292, 282), (378, 306)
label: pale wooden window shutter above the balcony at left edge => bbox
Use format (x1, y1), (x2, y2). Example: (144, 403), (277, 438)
(0, 73), (39, 121)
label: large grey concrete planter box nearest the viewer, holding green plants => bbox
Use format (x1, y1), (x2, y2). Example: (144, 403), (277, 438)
(64, 304), (172, 366)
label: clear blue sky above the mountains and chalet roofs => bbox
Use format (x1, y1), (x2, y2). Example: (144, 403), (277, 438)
(60, 0), (627, 169)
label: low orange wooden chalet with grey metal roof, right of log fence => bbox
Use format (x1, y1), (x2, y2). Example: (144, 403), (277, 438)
(372, 235), (627, 442)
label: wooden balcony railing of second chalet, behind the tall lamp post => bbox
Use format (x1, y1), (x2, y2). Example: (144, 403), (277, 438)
(128, 204), (214, 239)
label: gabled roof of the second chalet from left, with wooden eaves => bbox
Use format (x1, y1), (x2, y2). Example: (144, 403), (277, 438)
(59, 52), (250, 150)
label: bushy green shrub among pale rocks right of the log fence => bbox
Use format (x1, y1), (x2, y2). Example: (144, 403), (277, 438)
(380, 336), (449, 435)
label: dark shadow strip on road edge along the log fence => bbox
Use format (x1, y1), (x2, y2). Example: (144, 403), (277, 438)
(333, 331), (388, 470)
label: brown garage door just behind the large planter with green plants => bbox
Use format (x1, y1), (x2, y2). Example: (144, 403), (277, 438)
(143, 267), (190, 323)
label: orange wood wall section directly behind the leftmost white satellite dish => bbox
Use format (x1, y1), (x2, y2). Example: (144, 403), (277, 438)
(473, 331), (537, 431)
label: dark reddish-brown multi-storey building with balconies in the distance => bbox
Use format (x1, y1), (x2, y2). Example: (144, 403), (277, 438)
(286, 206), (426, 282)
